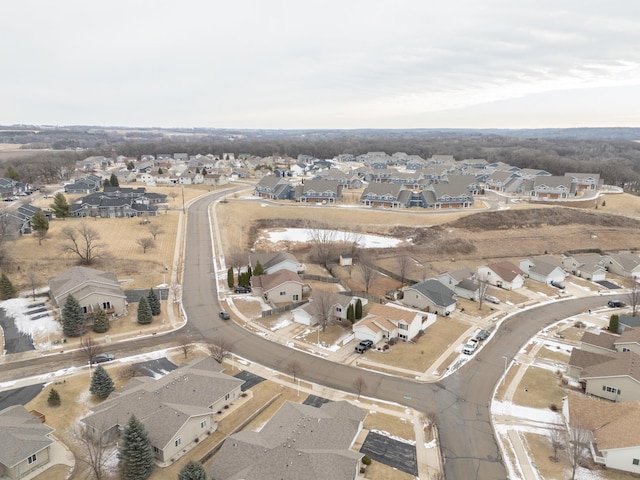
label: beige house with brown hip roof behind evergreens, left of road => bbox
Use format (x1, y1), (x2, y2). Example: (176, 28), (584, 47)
(49, 267), (127, 316)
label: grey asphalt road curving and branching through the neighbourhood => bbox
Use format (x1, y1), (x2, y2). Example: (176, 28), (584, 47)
(0, 191), (605, 480)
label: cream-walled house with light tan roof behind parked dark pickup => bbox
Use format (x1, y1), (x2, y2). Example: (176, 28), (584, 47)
(353, 303), (436, 344)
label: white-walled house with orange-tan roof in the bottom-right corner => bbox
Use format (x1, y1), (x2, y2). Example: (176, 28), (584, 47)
(562, 395), (640, 475)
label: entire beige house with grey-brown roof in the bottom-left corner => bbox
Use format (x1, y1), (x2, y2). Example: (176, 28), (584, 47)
(0, 405), (55, 480)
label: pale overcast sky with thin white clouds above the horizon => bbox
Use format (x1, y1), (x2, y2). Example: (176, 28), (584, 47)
(0, 0), (640, 128)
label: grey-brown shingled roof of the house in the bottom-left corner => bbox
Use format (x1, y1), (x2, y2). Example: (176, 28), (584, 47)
(0, 405), (54, 468)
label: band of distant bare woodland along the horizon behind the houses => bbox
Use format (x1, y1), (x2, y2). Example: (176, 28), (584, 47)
(0, 127), (640, 191)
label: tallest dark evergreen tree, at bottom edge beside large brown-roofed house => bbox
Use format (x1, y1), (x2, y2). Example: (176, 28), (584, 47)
(118, 415), (154, 480)
